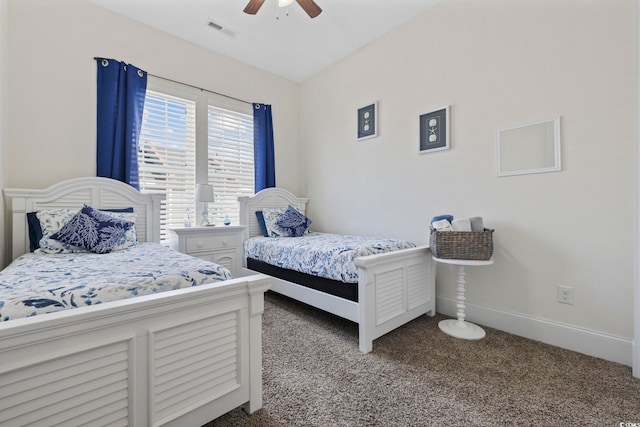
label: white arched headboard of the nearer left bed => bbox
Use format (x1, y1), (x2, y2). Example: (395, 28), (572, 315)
(4, 177), (164, 260)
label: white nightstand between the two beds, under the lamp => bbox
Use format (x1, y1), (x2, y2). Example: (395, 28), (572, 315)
(169, 225), (245, 277)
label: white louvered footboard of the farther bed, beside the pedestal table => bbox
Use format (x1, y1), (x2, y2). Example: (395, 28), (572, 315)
(355, 246), (436, 353)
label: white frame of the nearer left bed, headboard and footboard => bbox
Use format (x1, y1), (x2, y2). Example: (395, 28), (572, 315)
(0, 178), (270, 427)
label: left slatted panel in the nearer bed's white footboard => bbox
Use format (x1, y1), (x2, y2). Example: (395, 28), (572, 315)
(0, 340), (131, 427)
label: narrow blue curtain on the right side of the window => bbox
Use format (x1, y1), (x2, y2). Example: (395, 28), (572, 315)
(253, 104), (276, 193)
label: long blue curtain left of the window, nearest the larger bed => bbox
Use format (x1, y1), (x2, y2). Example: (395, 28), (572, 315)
(96, 58), (147, 189)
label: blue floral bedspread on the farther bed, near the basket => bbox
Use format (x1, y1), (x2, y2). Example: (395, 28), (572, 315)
(244, 232), (416, 283)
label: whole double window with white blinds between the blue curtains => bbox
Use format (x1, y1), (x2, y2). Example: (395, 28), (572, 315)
(138, 78), (254, 242)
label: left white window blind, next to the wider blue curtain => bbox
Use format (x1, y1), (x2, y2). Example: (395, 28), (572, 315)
(138, 90), (196, 242)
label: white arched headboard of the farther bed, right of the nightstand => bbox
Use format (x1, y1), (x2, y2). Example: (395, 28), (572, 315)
(238, 188), (309, 241)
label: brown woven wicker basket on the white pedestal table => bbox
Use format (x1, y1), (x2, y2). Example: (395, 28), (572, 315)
(429, 228), (493, 261)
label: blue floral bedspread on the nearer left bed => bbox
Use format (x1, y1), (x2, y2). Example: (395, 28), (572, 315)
(0, 243), (232, 321)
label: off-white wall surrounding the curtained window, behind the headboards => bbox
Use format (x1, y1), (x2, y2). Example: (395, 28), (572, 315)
(6, 0), (300, 191)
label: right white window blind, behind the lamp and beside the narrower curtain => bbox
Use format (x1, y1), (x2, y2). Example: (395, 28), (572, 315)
(207, 105), (254, 225)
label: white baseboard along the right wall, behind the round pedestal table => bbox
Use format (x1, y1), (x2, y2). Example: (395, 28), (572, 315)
(436, 297), (633, 366)
